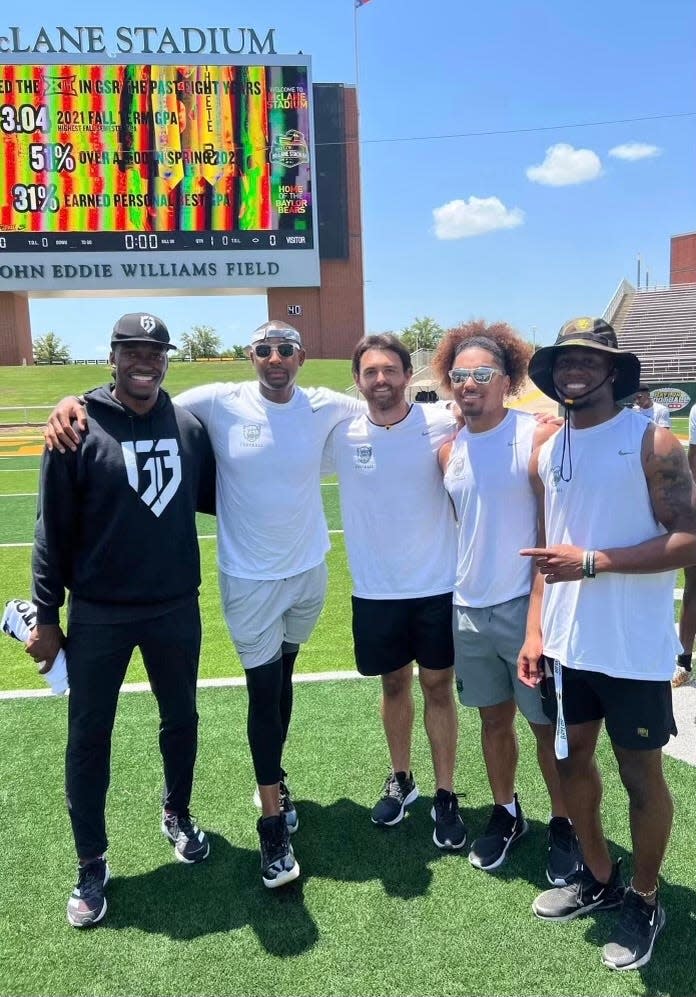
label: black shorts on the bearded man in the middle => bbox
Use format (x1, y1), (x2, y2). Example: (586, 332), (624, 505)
(352, 592), (454, 675)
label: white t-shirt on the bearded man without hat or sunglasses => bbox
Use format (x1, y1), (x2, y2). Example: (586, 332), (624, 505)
(324, 404), (457, 599)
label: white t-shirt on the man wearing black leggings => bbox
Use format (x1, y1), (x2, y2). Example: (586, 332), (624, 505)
(172, 381), (364, 581)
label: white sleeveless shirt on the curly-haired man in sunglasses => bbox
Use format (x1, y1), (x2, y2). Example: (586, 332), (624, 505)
(445, 409), (538, 608)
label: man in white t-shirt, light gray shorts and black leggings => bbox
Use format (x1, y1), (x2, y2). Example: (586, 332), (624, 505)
(46, 320), (363, 889)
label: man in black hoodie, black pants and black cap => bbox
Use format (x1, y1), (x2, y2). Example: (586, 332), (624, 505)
(28, 313), (215, 928)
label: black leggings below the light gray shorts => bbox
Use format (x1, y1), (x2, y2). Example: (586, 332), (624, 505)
(245, 642), (299, 786)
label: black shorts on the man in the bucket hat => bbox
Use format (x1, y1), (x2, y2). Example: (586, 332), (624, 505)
(540, 658), (677, 750)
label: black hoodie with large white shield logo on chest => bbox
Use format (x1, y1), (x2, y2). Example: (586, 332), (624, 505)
(32, 386), (215, 624)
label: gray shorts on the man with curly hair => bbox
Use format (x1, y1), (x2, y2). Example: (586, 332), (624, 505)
(452, 596), (549, 724)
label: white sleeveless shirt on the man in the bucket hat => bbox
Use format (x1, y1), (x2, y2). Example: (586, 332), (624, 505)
(539, 409), (680, 681)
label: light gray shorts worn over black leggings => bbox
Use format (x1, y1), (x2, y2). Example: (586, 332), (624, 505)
(220, 561), (328, 669)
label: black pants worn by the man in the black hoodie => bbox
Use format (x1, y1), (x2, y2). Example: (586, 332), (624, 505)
(65, 598), (201, 858)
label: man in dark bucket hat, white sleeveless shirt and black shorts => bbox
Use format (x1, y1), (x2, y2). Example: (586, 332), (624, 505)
(519, 317), (696, 970)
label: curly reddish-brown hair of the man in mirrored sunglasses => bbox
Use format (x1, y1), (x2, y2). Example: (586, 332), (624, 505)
(431, 319), (534, 395)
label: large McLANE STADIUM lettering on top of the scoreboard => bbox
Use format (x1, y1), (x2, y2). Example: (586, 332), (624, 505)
(0, 24), (277, 55)
